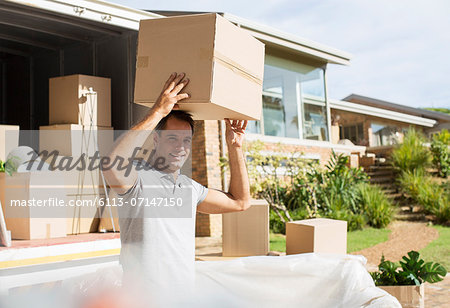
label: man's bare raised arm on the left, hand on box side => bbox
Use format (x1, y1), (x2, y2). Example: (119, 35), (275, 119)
(103, 73), (189, 194)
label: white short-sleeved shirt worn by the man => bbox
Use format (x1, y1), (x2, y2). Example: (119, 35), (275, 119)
(118, 169), (208, 289)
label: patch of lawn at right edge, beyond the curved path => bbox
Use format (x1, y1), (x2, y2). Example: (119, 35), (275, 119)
(419, 226), (450, 271)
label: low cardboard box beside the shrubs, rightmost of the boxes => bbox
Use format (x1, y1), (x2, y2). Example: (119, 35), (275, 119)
(286, 218), (347, 255)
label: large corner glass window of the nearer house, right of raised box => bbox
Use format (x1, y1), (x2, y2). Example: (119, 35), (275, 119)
(247, 57), (328, 140)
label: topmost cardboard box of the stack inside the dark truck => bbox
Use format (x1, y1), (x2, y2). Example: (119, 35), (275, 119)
(49, 75), (111, 126)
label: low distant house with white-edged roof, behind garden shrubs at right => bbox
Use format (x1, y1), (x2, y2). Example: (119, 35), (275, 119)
(330, 94), (450, 156)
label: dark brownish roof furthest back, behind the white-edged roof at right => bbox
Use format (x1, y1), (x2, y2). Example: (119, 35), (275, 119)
(343, 94), (450, 122)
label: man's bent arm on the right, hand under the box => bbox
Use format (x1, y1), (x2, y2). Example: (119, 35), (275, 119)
(197, 119), (250, 214)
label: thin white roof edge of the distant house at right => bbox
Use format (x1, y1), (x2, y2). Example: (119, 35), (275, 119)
(329, 99), (437, 127)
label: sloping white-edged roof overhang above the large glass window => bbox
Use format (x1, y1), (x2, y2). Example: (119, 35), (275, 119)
(147, 10), (352, 65)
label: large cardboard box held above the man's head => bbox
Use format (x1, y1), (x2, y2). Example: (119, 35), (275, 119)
(134, 13), (264, 120)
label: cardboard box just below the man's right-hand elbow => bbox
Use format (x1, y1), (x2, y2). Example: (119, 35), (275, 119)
(222, 200), (269, 257)
